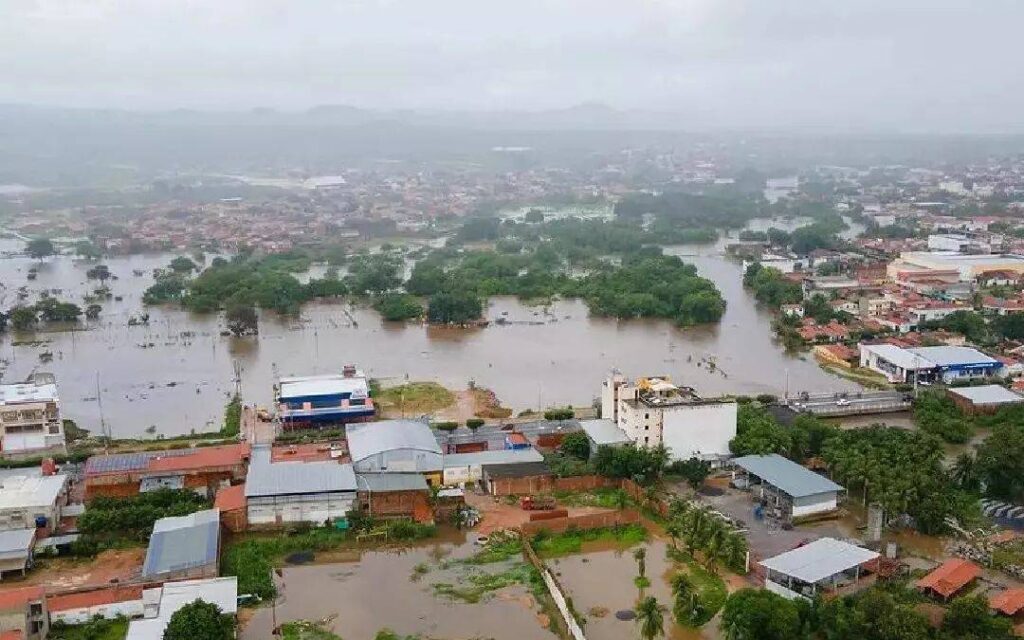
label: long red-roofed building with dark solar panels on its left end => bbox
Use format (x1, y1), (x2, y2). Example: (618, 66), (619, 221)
(85, 442), (249, 501)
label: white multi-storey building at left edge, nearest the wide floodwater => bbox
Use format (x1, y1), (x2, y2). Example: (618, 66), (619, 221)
(0, 374), (65, 455)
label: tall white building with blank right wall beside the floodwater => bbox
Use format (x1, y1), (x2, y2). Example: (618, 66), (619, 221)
(601, 371), (736, 463)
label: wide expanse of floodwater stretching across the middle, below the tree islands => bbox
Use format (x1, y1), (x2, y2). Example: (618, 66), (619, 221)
(0, 222), (859, 437)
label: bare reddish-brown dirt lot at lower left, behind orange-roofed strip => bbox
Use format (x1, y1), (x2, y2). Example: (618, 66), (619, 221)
(0, 547), (145, 592)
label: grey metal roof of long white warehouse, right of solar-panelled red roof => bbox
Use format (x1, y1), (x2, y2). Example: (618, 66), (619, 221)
(246, 446), (356, 498)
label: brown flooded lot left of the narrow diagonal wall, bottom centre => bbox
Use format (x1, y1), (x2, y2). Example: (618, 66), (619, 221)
(240, 539), (554, 640)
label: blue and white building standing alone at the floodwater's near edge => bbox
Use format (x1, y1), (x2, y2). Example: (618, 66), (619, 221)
(274, 366), (376, 428)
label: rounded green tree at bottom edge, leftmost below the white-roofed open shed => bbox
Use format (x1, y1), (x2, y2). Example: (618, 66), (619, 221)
(722, 589), (802, 640)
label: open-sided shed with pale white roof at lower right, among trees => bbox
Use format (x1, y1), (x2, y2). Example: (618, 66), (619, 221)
(761, 538), (879, 600)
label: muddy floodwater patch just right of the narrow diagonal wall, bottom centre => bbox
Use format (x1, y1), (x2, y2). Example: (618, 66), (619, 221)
(548, 539), (720, 640)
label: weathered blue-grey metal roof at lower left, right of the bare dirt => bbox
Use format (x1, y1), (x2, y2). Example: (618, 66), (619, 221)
(142, 509), (220, 578)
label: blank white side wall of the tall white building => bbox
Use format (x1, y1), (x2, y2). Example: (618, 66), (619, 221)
(662, 402), (736, 460)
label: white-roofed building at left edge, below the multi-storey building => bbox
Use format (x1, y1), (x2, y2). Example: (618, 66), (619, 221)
(0, 474), (69, 531)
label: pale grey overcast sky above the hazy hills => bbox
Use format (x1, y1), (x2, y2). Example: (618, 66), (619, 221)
(0, 0), (1024, 132)
